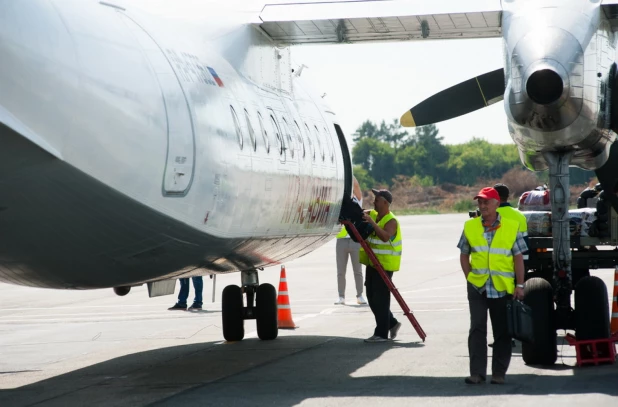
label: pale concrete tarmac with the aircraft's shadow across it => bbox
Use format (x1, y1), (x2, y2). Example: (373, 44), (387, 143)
(0, 215), (618, 407)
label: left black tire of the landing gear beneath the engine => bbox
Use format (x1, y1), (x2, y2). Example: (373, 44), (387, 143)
(521, 278), (558, 365)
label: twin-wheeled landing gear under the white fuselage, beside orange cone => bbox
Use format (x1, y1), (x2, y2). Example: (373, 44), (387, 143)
(221, 270), (279, 341)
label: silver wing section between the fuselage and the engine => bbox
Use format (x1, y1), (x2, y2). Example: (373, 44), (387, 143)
(259, 0), (502, 45)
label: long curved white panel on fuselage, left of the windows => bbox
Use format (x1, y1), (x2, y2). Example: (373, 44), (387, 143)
(122, 14), (195, 196)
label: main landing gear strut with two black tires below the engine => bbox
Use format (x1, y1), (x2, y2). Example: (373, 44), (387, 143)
(522, 152), (609, 365)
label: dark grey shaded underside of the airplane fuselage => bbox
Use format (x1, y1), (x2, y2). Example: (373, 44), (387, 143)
(0, 125), (331, 289)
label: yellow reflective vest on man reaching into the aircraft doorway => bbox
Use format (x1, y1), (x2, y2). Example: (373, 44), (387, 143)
(359, 210), (402, 271)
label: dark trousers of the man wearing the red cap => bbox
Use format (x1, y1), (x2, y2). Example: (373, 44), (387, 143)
(468, 283), (513, 377)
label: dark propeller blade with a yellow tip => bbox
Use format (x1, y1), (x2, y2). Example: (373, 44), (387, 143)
(399, 68), (505, 127)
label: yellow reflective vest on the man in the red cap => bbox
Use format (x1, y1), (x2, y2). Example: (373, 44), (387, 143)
(464, 216), (519, 294)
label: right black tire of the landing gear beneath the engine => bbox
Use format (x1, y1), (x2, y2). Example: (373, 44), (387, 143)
(575, 276), (609, 340)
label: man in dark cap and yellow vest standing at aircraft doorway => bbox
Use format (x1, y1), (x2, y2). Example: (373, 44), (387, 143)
(359, 189), (402, 343)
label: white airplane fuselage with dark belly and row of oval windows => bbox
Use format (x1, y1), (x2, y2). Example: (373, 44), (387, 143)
(0, 0), (351, 288)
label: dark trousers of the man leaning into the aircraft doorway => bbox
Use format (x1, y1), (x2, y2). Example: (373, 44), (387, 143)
(365, 266), (398, 345)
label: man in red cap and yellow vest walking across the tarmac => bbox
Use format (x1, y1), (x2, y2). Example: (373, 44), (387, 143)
(457, 188), (528, 384)
